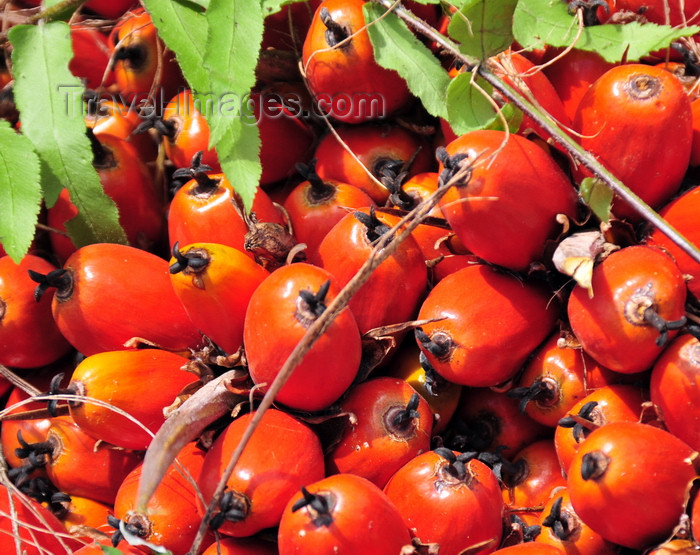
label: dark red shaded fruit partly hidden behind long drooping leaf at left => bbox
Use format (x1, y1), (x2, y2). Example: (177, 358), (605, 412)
(46, 133), (165, 261)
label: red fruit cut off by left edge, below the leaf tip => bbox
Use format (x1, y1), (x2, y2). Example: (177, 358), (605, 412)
(0, 254), (71, 368)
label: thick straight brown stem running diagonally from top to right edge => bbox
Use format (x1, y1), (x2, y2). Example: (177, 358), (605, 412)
(372, 0), (700, 263)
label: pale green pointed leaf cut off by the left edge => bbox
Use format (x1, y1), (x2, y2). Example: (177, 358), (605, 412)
(0, 120), (41, 264)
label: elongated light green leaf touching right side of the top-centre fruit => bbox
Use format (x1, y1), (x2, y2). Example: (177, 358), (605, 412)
(363, 2), (450, 118)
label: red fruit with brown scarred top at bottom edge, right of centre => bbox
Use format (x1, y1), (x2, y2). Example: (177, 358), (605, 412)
(384, 451), (505, 555)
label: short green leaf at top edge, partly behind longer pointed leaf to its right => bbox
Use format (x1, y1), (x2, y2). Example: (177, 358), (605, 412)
(143, 0), (209, 91)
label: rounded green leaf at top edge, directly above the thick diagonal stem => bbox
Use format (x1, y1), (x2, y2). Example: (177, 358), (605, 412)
(447, 0), (518, 60)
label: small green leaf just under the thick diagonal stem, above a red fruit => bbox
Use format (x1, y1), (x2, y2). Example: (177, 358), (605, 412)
(445, 73), (498, 135)
